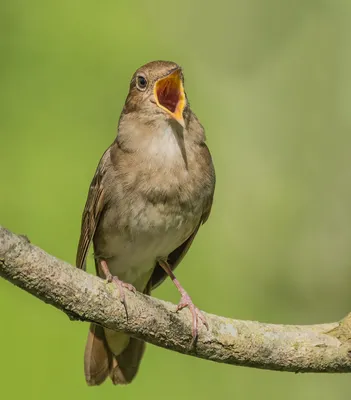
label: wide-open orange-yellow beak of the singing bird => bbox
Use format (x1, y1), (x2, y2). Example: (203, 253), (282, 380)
(154, 69), (186, 128)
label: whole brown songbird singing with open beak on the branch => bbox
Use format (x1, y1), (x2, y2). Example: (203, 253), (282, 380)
(76, 61), (215, 385)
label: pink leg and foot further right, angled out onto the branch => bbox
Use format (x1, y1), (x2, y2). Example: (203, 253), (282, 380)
(158, 259), (208, 344)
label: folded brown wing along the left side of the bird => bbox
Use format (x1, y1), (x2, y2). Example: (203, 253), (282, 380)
(76, 149), (110, 270)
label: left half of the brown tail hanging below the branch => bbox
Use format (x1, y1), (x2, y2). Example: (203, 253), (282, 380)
(84, 324), (113, 386)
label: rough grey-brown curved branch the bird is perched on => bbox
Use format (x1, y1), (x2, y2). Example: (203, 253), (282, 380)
(0, 227), (351, 372)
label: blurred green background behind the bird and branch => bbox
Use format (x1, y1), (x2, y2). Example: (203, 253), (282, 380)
(0, 0), (351, 400)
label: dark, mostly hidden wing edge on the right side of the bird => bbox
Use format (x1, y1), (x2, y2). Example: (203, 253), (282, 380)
(150, 144), (215, 289)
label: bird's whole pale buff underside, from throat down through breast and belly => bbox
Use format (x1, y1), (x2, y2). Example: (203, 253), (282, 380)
(94, 123), (209, 290)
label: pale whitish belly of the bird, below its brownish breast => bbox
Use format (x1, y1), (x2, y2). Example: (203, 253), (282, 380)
(96, 202), (201, 291)
